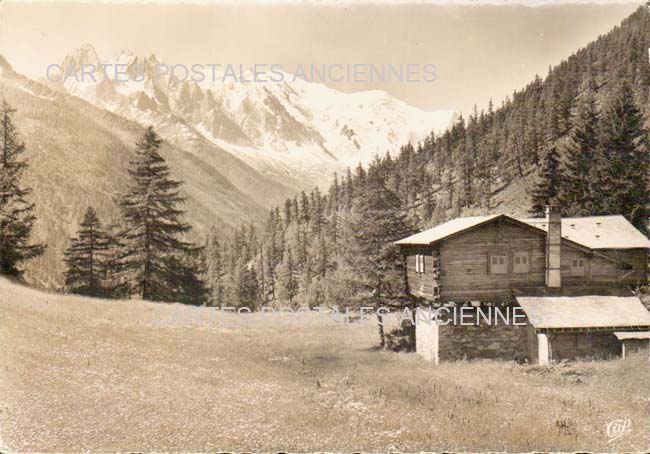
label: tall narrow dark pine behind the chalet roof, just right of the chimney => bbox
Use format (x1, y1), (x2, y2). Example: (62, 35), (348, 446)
(561, 90), (598, 216)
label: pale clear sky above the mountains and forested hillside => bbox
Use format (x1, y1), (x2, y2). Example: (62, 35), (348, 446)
(0, 0), (639, 112)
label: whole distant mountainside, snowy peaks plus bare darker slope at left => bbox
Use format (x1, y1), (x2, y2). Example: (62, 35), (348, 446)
(0, 46), (452, 287)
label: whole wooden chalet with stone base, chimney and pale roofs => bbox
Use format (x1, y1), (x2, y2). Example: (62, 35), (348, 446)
(397, 206), (650, 363)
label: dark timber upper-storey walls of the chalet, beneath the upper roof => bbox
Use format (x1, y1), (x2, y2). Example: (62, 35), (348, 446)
(402, 219), (648, 302)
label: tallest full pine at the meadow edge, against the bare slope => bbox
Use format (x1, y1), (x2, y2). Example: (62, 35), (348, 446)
(120, 127), (202, 302)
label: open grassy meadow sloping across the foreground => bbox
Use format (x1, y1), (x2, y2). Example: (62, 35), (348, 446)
(0, 280), (650, 452)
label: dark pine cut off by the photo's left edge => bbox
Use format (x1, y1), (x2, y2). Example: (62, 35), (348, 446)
(0, 101), (45, 277)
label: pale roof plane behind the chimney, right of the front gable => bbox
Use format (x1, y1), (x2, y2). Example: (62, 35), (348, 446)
(520, 215), (650, 249)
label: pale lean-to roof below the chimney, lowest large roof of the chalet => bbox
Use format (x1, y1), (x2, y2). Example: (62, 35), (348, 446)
(517, 295), (650, 328)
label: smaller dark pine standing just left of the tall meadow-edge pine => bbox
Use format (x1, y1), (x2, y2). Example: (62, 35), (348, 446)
(65, 207), (111, 297)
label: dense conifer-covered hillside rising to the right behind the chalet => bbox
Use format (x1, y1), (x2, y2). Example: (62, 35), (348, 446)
(209, 8), (650, 304)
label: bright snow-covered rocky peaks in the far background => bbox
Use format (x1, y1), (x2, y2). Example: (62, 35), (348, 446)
(53, 44), (454, 189)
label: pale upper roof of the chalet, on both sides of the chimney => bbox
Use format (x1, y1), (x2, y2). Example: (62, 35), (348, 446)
(396, 214), (650, 249)
